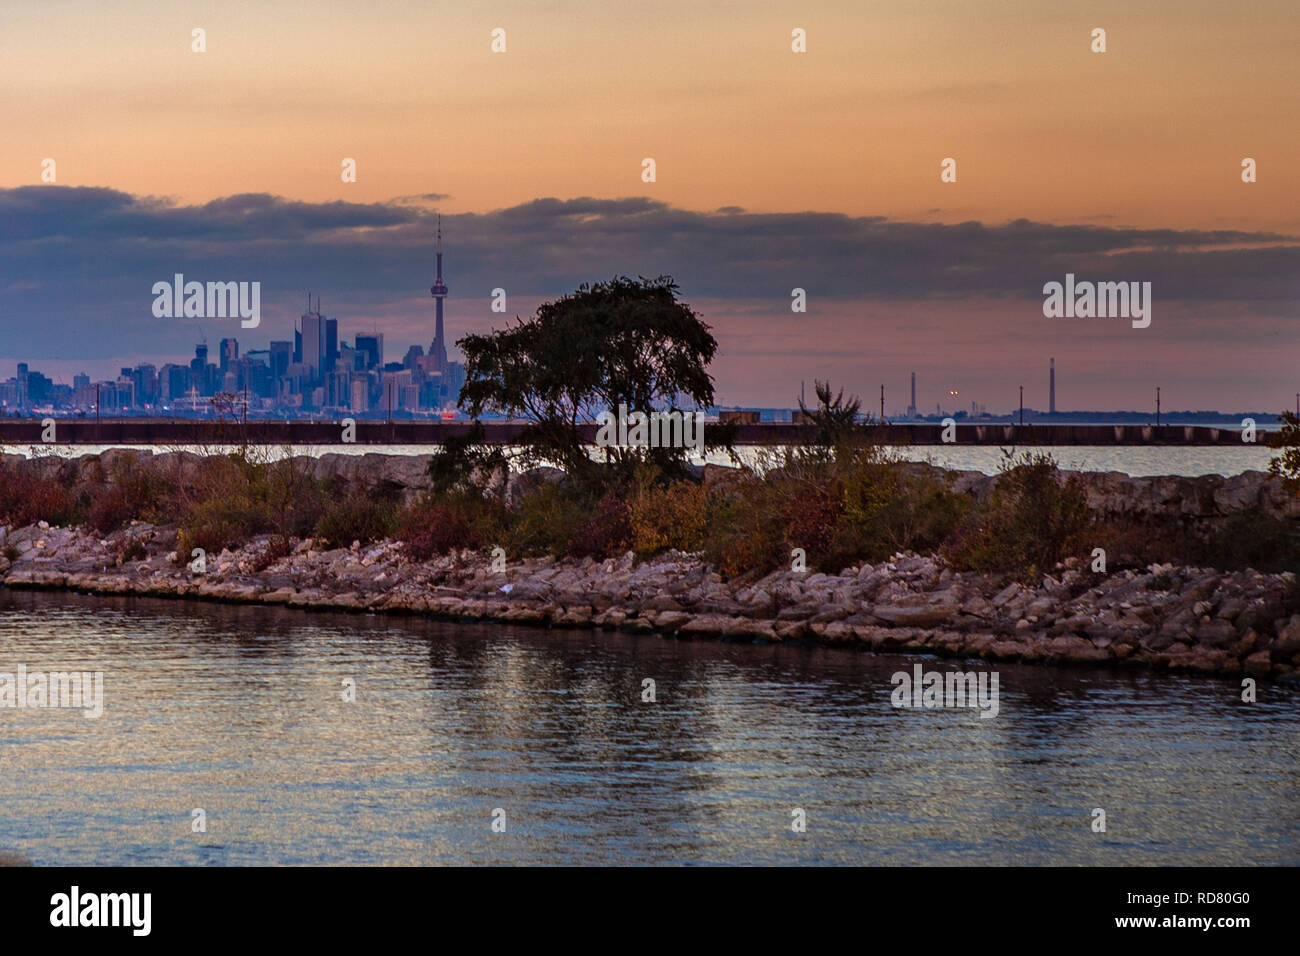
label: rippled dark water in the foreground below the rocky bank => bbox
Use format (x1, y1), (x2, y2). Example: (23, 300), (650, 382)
(0, 589), (1300, 865)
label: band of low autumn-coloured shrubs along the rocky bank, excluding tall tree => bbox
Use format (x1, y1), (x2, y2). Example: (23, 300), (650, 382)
(0, 398), (1300, 581)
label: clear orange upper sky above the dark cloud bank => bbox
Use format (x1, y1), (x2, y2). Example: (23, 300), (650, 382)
(0, 0), (1300, 234)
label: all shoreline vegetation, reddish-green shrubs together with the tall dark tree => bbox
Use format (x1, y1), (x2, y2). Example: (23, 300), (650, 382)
(0, 277), (1300, 581)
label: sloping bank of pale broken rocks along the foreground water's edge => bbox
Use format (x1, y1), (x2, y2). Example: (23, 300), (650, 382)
(0, 522), (1300, 679)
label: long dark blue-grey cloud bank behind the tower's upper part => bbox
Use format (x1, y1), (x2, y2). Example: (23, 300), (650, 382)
(0, 186), (1300, 374)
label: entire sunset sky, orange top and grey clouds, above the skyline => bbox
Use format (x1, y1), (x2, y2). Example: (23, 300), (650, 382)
(0, 0), (1300, 410)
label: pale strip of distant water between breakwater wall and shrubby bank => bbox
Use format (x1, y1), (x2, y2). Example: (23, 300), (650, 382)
(0, 444), (1275, 477)
